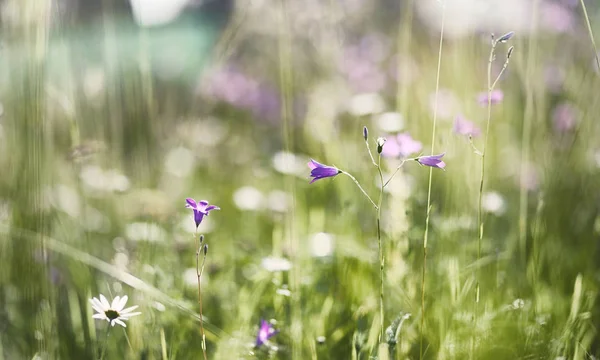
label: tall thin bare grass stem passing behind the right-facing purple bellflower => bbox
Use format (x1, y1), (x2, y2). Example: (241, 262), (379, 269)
(419, 2), (446, 359)
